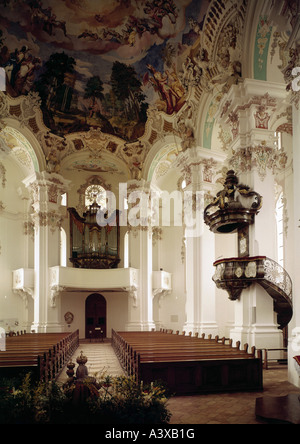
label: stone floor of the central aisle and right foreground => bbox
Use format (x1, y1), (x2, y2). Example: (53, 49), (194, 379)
(59, 341), (300, 425)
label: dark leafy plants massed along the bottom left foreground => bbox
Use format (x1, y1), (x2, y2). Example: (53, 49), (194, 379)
(0, 374), (171, 424)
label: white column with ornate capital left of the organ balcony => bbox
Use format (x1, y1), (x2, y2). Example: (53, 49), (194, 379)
(24, 172), (69, 333)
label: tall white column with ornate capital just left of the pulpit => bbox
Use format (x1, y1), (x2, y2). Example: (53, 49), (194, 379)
(178, 147), (220, 335)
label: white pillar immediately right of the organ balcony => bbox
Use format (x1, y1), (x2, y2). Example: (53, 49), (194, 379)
(126, 181), (155, 331)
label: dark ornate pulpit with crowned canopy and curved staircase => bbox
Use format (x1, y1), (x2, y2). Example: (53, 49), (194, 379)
(204, 171), (293, 329)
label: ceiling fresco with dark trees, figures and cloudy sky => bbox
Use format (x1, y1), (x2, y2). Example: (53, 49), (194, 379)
(0, 0), (210, 142)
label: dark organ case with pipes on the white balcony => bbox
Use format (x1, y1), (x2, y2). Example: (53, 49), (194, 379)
(68, 202), (120, 269)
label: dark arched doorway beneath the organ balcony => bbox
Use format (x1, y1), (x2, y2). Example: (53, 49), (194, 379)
(85, 293), (106, 339)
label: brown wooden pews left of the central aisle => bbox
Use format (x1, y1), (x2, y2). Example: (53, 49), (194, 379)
(0, 330), (79, 382)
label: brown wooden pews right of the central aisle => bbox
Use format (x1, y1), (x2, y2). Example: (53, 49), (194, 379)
(112, 330), (263, 395)
